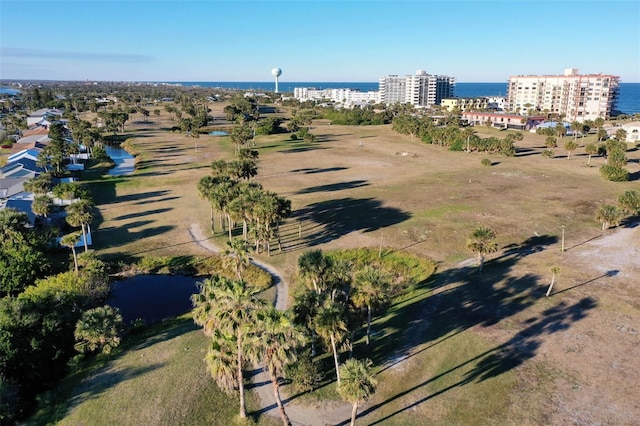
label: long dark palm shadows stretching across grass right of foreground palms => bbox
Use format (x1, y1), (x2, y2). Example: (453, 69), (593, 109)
(320, 236), (596, 424)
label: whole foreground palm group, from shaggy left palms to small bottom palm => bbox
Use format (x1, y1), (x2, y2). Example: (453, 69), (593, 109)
(192, 245), (382, 425)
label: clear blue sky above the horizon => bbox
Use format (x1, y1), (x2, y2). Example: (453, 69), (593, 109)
(0, 0), (640, 82)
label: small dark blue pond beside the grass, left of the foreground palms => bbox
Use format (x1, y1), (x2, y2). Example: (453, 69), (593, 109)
(106, 275), (203, 324)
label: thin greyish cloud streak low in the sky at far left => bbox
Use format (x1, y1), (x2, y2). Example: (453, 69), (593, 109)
(0, 47), (155, 63)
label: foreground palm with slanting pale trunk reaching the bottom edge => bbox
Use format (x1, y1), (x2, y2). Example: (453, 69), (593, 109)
(257, 307), (306, 426)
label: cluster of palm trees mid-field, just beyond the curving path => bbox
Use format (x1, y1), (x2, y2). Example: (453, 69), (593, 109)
(197, 149), (291, 255)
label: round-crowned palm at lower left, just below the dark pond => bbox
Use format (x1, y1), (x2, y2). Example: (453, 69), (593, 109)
(73, 305), (122, 354)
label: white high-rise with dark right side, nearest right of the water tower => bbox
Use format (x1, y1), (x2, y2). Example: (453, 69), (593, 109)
(380, 70), (456, 108)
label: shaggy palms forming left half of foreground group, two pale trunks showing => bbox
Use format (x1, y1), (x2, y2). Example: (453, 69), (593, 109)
(192, 275), (305, 425)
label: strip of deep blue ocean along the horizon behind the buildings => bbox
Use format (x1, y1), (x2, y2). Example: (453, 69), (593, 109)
(166, 81), (640, 114)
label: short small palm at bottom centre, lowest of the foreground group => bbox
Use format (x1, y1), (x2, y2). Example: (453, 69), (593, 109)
(338, 358), (378, 426)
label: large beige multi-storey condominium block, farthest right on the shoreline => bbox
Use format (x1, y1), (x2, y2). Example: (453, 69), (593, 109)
(507, 68), (620, 122)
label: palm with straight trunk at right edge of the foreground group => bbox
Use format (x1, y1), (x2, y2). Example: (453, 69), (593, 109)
(351, 266), (390, 345)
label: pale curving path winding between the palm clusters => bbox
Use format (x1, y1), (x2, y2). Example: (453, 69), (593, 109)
(189, 223), (351, 426)
